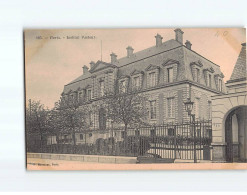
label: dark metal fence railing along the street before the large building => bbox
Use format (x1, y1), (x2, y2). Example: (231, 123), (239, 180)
(27, 121), (212, 160)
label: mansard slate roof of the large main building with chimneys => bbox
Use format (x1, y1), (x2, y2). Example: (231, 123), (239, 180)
(63, 35), (225, 93)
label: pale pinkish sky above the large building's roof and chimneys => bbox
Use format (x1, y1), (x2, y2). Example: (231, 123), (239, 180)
(25, 28), (246, 108)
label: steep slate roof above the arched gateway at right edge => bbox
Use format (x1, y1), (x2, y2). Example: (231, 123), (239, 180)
(228, 43), (247, 82)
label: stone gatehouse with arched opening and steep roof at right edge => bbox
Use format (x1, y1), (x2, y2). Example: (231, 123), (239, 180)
(212, 43), (247, 162)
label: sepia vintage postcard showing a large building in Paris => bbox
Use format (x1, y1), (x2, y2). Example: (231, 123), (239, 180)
(24, 28), (247, 170)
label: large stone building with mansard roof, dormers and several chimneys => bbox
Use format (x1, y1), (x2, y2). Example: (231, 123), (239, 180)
(61, 29), (226, 145)
